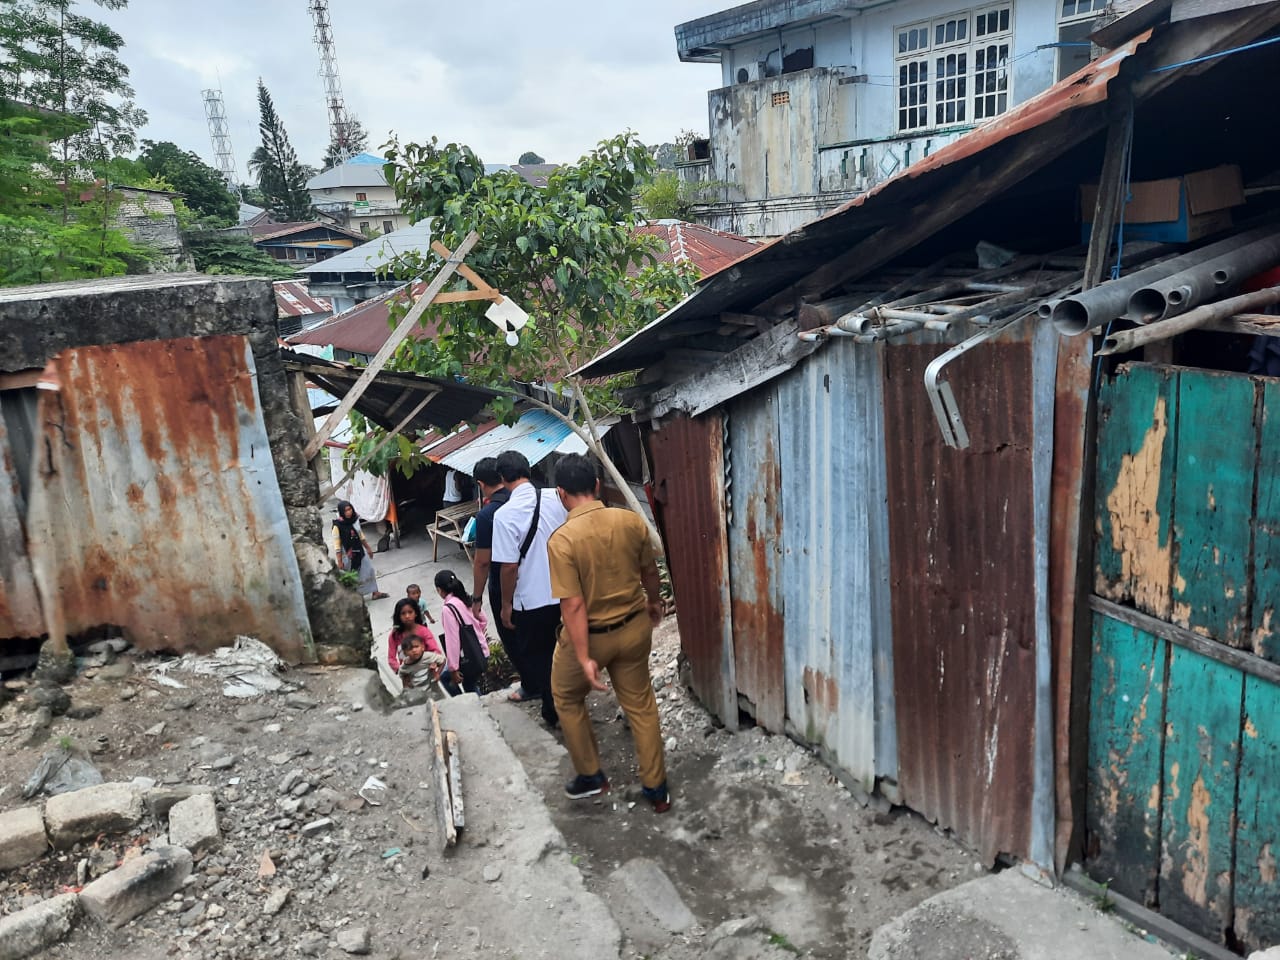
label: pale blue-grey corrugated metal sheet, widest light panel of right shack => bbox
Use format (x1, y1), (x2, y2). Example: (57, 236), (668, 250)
(773, 340), (897, 791)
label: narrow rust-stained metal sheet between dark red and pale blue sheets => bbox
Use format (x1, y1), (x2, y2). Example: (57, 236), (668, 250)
(724, 388), (783, 733)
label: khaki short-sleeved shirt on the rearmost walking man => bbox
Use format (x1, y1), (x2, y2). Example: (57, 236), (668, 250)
(547, 500), (653, 626)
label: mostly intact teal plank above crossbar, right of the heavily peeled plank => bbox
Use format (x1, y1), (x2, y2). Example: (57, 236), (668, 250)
(1170, 370), (1257, 646)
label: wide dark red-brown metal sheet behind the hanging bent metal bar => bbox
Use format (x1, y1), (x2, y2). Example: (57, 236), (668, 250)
(884, 337), (1037, 861)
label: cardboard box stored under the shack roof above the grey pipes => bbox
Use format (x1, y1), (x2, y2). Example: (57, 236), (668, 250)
(1080, 164), (1244, 243)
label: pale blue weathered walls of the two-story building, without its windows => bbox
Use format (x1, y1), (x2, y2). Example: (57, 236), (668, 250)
(680, 0), (1060, 236)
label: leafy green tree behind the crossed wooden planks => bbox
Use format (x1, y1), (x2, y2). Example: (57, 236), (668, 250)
(373, 133), (692, 535)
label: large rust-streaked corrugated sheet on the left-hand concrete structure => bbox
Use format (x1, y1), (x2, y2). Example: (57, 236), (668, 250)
(28, 337), (315, 662)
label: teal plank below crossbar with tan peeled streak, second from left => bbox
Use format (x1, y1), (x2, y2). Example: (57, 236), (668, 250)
(1160, 646), (1244, 940)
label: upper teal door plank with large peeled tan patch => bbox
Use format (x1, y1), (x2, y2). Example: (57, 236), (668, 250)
(1094, 364), (1178, 620)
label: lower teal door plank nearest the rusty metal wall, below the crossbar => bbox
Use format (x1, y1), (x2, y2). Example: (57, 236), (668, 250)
(1085, 613), (1169, 905)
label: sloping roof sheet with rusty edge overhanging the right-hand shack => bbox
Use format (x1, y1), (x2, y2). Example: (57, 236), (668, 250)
(580, 32), (1151, 376)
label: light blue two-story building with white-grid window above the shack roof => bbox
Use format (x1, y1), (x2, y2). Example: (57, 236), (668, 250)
(676, 0), (1135, 237)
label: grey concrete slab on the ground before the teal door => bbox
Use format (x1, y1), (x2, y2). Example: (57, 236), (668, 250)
(868, 870), (1170, 960)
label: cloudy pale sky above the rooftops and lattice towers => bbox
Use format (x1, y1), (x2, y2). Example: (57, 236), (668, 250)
(93, 0), (733, 172)
